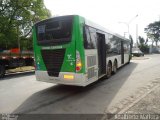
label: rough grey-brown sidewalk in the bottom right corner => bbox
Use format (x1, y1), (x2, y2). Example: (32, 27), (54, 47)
(105, 85), (160, 120)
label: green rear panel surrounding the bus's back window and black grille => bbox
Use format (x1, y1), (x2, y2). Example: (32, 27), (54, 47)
(33, 17), (77, 76)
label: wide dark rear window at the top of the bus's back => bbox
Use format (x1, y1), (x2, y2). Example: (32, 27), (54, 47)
(37, 19), (72, 45)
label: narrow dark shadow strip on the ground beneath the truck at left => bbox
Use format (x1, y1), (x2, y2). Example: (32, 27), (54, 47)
(0, 71), (35, 80)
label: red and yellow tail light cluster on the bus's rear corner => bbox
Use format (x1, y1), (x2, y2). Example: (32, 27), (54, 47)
(76, 51), (82, 72)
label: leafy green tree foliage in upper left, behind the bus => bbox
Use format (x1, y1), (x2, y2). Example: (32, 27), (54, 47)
(0, 0), (51, 49)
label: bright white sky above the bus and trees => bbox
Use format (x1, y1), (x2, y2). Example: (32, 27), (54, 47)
(44, 0), (160, 42)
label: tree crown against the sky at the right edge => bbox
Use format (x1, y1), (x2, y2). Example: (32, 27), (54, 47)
(145, 21), (160, 46)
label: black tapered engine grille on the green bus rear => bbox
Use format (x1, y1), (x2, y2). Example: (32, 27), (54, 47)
(41, 49), (65, 77)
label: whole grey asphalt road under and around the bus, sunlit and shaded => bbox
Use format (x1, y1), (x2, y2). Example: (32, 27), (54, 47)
(0, 55), (160, 114)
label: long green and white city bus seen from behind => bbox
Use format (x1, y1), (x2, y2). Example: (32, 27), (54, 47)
(33, 15), (131, 86)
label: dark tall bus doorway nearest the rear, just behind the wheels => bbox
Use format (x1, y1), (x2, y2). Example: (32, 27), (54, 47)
(97, 33), (106, 76)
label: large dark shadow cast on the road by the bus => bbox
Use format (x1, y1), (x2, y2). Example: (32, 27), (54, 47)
(13, 62), (137, 114)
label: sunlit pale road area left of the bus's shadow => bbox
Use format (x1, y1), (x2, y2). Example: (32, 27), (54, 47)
(0, 72), (55, 113)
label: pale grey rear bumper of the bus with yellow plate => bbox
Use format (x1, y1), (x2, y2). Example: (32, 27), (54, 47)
(35, 71), (88, 86)
